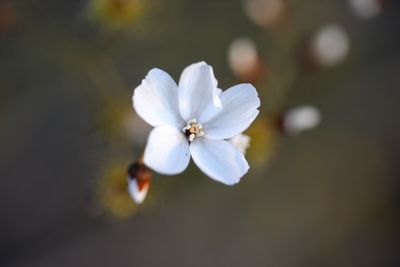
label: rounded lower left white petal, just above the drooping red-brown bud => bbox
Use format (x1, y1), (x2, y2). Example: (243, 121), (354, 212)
(143, 125), (190, 175)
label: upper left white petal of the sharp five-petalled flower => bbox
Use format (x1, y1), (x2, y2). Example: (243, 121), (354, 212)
(132, 69), (184, 128)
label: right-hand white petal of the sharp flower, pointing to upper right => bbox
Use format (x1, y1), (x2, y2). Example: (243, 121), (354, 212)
(203, 84), (260, 139)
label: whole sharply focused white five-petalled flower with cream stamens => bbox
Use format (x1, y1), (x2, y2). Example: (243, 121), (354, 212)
(133, 62), (260, 185)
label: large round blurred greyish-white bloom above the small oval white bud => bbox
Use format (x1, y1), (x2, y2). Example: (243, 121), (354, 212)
(311, 24), (350, 67)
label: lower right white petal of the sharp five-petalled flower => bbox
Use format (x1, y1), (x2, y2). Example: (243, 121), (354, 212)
(190, 138), (249, 185)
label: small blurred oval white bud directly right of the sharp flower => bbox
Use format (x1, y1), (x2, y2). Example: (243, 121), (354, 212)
(283, 105), (321, 135)
